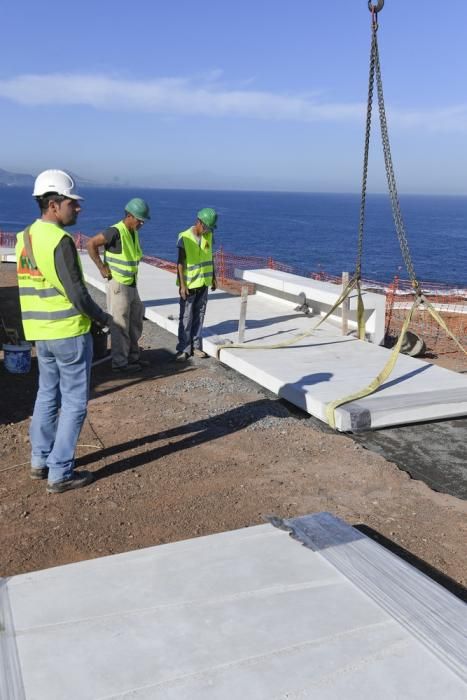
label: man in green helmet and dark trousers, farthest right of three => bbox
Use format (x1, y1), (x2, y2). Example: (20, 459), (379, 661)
(175, 207), (217, 362)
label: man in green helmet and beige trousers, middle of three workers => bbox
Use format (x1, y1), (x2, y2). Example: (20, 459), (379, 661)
(87, 197), (151, 373)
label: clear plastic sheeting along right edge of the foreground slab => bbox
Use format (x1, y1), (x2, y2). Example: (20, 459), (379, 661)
(271, 513), (467, 682)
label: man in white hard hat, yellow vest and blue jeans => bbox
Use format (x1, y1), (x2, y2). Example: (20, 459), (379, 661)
(16, 170), (112, 493)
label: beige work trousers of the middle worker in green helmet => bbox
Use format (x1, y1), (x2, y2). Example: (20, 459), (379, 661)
(107, 279), (144, 367)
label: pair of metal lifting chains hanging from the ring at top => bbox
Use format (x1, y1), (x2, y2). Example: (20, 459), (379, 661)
(355, 0), (421, 295)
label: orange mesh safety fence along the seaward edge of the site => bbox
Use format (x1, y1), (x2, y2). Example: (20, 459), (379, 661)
(0, 231), (467, 372)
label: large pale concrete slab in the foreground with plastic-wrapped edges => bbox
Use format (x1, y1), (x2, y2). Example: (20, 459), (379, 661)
(0, 513), (467, 700)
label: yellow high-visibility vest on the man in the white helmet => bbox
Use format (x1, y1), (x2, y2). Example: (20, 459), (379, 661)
(16, 219), (91, 340)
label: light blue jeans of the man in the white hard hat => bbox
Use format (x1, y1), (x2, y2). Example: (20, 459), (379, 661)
(29, 333), (92, 484)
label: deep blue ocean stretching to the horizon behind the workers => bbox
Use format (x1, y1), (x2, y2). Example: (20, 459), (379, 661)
(0, 187), (467, 287)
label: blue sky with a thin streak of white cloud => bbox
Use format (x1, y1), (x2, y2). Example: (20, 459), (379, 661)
(0, 0), (467, 195)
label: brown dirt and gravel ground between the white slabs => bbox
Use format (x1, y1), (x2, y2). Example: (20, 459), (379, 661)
(0, 264), (467, 593)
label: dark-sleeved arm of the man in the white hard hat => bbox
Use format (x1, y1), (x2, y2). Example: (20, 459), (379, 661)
(54, 236), (112, 326)
